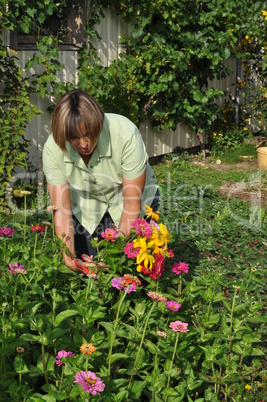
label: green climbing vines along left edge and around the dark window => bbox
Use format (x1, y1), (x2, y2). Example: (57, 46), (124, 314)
(0, 0), (88, 213)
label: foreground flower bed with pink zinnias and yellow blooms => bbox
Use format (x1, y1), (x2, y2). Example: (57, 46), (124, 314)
(0, 199), (266, 402)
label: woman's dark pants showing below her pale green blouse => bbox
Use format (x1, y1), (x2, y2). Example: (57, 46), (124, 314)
(73, 190), (159, 258)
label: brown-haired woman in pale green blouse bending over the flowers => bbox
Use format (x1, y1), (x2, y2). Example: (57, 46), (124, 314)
(43, 89), (158, 272)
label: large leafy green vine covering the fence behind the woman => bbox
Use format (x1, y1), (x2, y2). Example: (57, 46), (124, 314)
(79, 0), (264, 137)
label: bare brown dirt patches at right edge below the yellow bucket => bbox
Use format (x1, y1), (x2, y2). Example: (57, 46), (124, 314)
(193, 160), (267, 208)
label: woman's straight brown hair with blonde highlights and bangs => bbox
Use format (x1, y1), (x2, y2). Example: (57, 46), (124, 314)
(51, 89), (104, 151)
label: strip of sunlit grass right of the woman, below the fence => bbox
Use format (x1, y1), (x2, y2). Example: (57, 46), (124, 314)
(153, 144), (267, 203)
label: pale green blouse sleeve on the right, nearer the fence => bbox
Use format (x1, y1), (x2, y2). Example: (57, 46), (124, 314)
(121, 127), (148, 179)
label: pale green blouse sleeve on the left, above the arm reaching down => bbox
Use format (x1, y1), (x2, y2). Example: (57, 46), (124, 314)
(43, 137), (66, 186)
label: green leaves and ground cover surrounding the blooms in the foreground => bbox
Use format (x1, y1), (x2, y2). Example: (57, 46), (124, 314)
(0, 160), (266, 402)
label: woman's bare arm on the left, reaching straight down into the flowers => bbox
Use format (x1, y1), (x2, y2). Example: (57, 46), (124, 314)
(47, 183), (79, 272)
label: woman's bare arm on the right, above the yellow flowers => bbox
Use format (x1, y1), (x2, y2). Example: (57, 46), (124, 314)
(119, 171), (146, 236)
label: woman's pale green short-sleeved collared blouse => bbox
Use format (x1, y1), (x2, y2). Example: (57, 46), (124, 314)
(43, 113), (157, 233)
